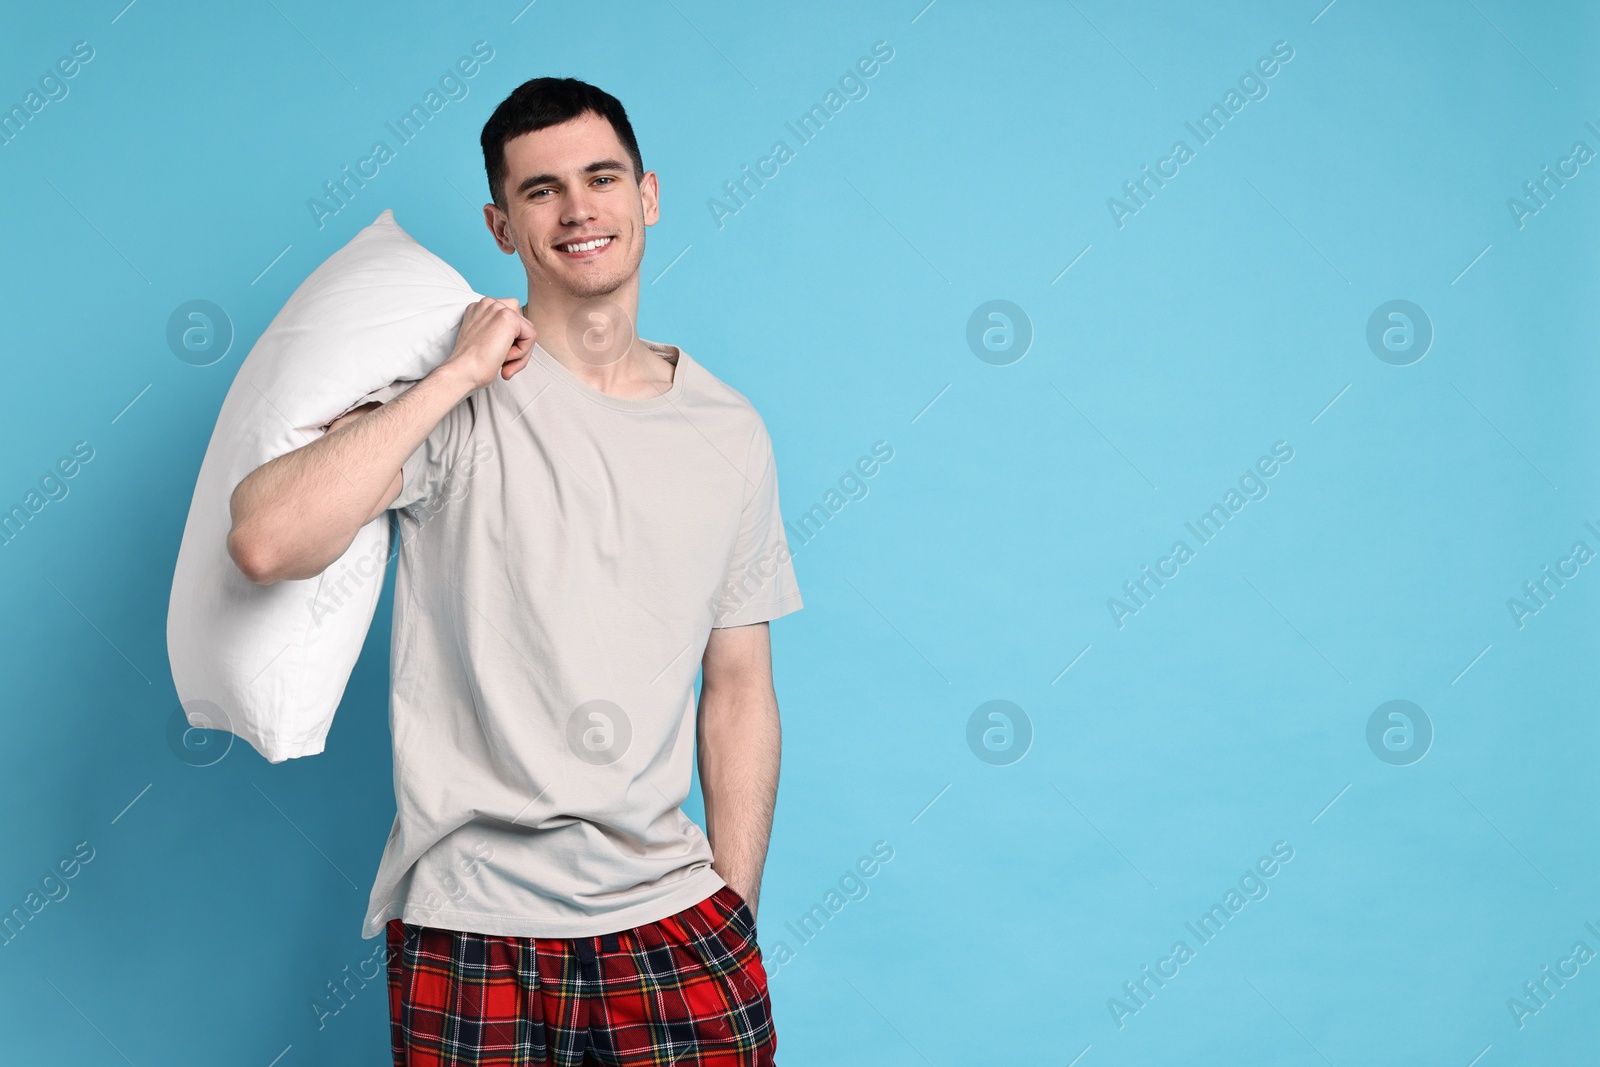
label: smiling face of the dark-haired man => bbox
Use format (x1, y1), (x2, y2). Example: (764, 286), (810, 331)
(485, 112), (659, 298)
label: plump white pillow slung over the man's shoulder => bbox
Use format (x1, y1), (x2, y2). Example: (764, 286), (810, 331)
(166, 210), (480, 763)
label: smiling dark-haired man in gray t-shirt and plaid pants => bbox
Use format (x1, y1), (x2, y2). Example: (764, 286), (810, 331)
(229, 78), (802, 1067)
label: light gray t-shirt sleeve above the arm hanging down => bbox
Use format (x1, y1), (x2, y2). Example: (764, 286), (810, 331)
(712, 424), (805, 627)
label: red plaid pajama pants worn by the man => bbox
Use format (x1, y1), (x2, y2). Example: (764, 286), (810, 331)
(386, 886), (778, 1067)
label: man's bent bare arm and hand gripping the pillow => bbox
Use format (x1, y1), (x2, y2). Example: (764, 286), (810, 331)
(227, 298), (534, 585)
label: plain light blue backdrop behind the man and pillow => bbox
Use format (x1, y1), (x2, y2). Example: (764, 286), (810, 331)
(0, 0), (1600, 1067)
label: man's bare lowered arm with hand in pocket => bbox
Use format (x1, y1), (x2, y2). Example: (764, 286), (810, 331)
(696, 622), (782, 917)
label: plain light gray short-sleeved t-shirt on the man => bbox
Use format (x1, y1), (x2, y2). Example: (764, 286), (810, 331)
(362, 341), (802, 937)
